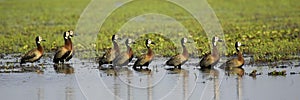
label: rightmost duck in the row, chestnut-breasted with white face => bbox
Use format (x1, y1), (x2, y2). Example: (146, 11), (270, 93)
(220, 42), (245, 68)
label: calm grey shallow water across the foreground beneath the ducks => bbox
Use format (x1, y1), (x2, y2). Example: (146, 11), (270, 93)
(0, 54), (300, 100)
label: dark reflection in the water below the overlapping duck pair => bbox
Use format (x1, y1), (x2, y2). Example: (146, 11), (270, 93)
(53, 64), (74, 74)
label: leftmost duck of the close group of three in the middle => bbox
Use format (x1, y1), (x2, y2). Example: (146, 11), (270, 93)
(99, 35), (120, 66)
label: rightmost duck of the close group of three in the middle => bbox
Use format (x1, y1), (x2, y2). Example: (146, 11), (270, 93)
(133, 39), (155, 68)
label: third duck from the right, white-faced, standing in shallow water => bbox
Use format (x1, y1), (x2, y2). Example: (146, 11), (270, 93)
(166, 38), (189, 69)
